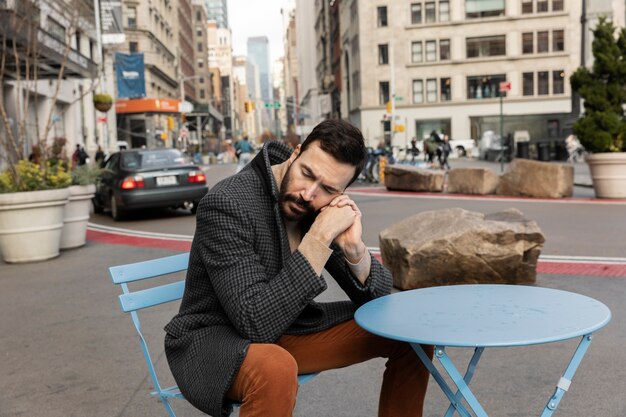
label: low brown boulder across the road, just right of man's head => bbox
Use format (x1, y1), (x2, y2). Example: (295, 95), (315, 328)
(385, 165), (445, 192)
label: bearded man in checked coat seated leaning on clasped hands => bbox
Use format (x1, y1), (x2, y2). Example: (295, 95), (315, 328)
(165, 120), (432, 417)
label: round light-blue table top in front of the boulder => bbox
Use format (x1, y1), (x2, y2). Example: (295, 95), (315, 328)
(354, 284), (611, 347)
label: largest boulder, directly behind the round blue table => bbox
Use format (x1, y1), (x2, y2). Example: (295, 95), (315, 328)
(379, 208), (545, 290)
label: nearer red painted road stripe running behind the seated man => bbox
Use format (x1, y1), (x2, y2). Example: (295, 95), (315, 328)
(87, 229), (626, 277)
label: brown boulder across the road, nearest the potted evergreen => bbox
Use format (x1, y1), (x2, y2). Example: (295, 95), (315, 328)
(496, 159), (574, 198)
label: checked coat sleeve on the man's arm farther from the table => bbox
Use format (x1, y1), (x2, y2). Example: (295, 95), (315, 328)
(194, 194), (326, 343)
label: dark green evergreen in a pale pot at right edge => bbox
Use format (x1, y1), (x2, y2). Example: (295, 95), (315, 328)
(570, 18), (626, 198)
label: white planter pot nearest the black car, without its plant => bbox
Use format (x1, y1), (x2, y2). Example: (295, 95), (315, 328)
(61, 184), (96, 249)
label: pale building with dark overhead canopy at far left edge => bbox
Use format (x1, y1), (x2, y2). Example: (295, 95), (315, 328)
(0, 0), (98, 166)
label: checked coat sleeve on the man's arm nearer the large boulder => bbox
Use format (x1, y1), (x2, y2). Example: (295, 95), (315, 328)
(326, 247), (392, 307)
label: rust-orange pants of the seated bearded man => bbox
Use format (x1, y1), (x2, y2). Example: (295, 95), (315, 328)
(227, 320), (433, 417)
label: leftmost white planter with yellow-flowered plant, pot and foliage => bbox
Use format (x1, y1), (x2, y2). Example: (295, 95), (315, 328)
(0, 139), (71, 263)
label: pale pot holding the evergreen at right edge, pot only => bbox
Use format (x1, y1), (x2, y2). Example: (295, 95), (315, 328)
(585, 152), (626, 198)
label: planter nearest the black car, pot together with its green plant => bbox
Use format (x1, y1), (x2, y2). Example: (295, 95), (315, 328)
(61, 164), (103, 249)
